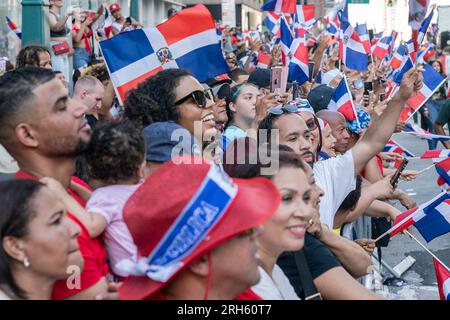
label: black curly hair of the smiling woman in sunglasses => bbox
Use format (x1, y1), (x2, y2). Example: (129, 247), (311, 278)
(125, 69), (192, 126)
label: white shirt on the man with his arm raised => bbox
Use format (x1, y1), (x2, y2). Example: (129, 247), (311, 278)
(314, 150), (356, 229)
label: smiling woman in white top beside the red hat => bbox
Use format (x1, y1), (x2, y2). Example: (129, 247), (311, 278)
(225, 152), (317, 300)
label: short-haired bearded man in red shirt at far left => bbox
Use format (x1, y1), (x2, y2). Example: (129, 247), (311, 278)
(0, 68), (108, 299)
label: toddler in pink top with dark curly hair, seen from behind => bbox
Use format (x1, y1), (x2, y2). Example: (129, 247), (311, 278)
(45, 122), (146, 277)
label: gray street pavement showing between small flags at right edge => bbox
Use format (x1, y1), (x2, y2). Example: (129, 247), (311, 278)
(382, 133), (450, 300)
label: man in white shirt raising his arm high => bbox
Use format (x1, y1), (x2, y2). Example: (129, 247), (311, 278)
(258, 69), (422, 228)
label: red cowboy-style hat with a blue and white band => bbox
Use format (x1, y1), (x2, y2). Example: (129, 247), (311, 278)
(119, 156), (281, 300)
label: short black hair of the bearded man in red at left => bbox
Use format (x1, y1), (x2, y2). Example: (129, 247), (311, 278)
(0, 67), (55, 143)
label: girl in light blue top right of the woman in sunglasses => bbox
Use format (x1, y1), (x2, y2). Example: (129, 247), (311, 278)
(223, 83), (259, 149)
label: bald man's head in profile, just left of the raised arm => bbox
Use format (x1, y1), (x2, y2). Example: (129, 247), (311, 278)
(316, 110), (350, 154)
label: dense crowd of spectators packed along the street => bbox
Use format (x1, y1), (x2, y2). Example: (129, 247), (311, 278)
(0, 0), (450, 300)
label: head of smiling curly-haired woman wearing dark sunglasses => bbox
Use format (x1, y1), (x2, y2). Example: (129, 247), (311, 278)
(125, 69), (216, 146)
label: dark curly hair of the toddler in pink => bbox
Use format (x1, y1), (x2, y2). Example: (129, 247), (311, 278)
(85, 121), (146, 184)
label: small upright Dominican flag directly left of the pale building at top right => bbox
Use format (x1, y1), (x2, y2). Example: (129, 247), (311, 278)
(339, 14), (369, 71)
